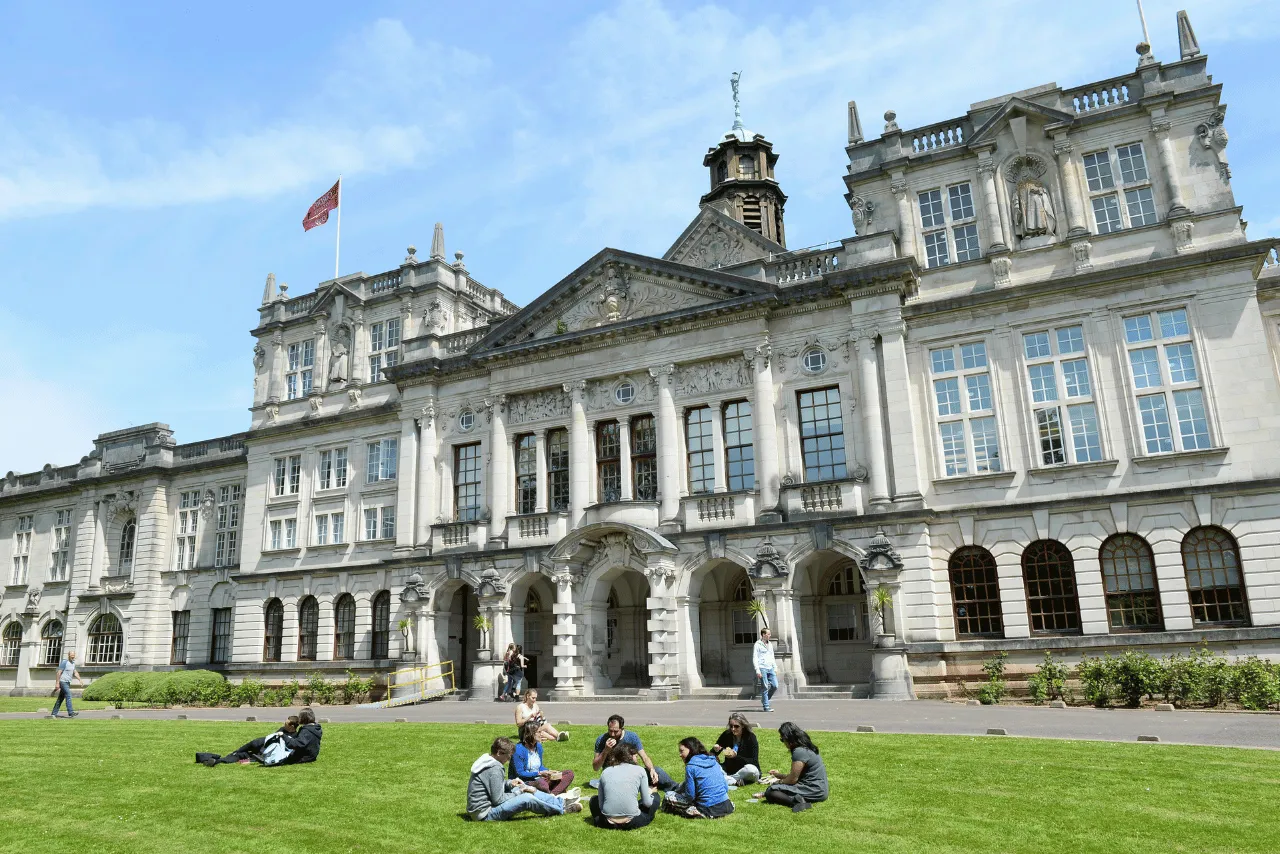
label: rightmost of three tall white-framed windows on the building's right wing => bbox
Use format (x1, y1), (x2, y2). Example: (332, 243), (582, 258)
(1124, 309), (1213, 455)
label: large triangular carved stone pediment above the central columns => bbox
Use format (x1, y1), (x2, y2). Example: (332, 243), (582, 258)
(471, 250), (777, 352)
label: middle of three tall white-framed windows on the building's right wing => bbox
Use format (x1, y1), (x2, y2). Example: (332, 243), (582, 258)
(1023, 325), (1102, 466)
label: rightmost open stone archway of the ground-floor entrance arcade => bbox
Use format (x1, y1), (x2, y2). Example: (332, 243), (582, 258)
(796, 552), (873, 685)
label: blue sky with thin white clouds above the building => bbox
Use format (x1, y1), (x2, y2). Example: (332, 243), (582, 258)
(0, 0), (1280, 471)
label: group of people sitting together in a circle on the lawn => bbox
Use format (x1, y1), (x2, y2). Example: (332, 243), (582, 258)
(467, 711), (828, 830)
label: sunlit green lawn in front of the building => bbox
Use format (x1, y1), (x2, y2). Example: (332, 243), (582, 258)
(0, 720), (1280, 854)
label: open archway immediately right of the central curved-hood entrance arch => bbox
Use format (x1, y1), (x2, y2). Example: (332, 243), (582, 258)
(690, 561), (759, 686)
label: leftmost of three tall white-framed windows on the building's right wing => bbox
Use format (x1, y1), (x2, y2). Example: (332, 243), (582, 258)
(929, 341), (1001, 478)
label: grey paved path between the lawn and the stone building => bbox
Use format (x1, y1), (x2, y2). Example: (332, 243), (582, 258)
(0, 698), (1280, 749)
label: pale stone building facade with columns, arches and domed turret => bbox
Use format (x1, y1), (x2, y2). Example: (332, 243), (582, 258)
(0, 13), (1280, 698)
